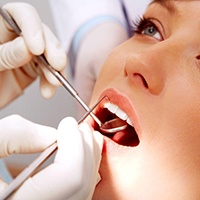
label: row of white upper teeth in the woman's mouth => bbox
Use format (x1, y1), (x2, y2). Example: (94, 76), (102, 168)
(104, 102), (133, 126)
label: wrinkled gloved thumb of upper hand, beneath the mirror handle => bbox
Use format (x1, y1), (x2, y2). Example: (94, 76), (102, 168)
(0, 37), (32, 71)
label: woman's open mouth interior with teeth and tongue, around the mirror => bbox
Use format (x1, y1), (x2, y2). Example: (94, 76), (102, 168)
(94, 102), (140, 147)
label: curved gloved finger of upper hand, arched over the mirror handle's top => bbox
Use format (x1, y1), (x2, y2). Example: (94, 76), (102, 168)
(3, 2), (45, 55)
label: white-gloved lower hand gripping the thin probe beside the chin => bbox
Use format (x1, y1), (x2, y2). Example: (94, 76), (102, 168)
(0, 118), (103, 200)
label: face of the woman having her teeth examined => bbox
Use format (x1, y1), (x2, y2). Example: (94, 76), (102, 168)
(91, 0), (200, 200)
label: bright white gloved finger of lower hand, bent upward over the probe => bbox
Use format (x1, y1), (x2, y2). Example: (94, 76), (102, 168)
(9, 118), (85, 200)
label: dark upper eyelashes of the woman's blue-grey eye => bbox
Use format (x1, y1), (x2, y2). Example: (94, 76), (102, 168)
(130, 17), (162, 40)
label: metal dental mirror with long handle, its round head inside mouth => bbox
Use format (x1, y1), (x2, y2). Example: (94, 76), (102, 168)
(0, 7), (128, 134)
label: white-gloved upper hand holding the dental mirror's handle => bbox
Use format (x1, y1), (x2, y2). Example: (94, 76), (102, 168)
(0, 2), (67, 107)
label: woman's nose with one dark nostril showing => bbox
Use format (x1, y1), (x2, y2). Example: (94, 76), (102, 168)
(124, 44), (171, 95)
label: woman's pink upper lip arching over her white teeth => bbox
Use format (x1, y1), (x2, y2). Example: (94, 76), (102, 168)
(90, 88), (141, 146)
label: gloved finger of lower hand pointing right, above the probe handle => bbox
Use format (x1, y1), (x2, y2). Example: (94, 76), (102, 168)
(0, 115), (57, 157)
